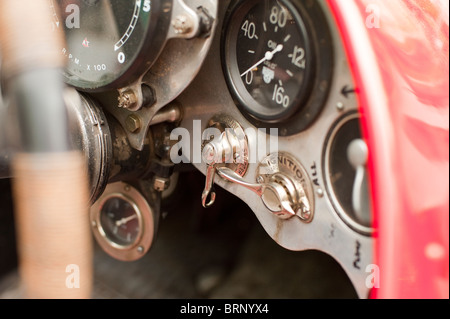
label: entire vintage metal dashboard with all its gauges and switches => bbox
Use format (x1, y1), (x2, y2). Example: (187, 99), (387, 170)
(1, 0), (374, 297)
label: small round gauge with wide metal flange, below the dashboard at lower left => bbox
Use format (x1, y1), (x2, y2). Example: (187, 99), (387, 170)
(90, 183), (155, 261)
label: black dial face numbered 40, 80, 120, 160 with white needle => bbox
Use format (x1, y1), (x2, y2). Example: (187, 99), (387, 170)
(224, 0), (314, 122)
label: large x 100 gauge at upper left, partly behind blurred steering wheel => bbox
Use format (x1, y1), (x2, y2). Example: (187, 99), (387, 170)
(51, 0), (172, 90)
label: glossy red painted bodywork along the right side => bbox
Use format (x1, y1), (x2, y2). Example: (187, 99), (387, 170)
(328, 0), (449, 298)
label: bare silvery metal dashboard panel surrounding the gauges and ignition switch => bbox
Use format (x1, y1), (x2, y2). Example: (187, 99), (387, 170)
(178, 0), (374, 298)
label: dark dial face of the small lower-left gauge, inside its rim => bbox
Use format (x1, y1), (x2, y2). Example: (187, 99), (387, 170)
(100, 197), (141, 247)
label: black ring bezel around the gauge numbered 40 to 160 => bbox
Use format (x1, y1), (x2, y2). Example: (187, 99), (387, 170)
(221, 0), (334, 136)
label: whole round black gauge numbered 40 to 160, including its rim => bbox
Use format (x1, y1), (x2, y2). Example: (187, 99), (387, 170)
(222, 0), (332, 130)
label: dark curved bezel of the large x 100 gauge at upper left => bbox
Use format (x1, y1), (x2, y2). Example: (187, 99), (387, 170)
(63, 0), (173, 92)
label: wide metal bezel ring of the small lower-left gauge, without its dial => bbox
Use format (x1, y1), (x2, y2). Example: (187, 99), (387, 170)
(90, 182), (155, 261)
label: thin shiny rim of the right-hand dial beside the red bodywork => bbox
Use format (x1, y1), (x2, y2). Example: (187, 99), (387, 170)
(322, 111), (374, 236)
